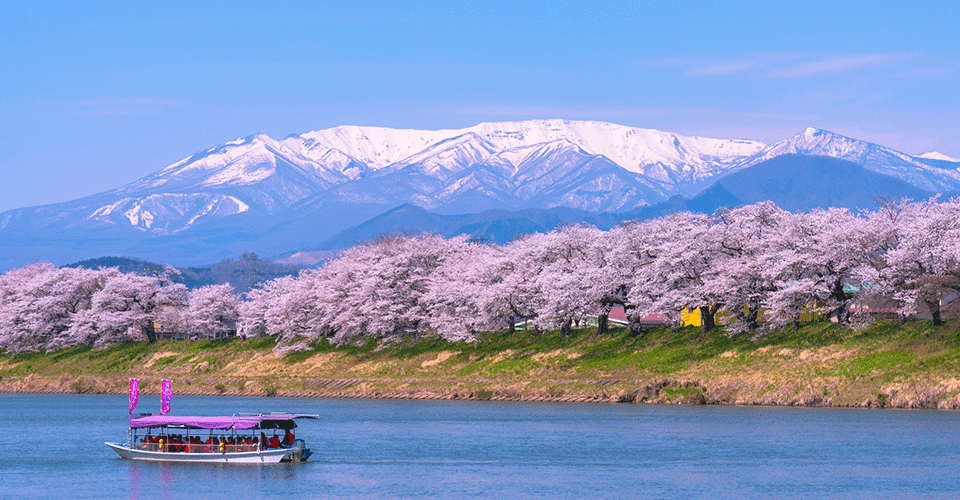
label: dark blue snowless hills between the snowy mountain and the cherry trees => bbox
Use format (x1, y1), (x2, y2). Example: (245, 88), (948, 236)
(302, 154), (944, 258)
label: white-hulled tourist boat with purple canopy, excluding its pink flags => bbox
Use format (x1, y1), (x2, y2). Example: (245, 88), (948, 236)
(104, 413), (318, 464)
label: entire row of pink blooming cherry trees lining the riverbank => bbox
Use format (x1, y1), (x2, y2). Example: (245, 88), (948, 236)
(0, 199), (960, 352)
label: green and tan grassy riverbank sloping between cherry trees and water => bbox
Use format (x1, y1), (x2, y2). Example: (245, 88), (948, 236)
(0, 321), (960, 409)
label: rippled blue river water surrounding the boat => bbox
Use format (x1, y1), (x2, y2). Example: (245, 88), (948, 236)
(0, 394), (960, 500)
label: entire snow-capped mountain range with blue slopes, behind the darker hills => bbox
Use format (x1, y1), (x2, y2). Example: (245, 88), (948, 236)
(0, 120), (960, 270)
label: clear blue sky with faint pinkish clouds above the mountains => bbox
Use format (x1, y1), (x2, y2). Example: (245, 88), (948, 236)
(0, 0), (960, 211)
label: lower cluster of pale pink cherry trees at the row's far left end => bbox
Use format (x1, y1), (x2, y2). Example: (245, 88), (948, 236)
(0, 263), (240, 353)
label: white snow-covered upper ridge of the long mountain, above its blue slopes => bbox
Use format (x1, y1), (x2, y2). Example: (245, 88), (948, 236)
(126, 120), (764, 196)
